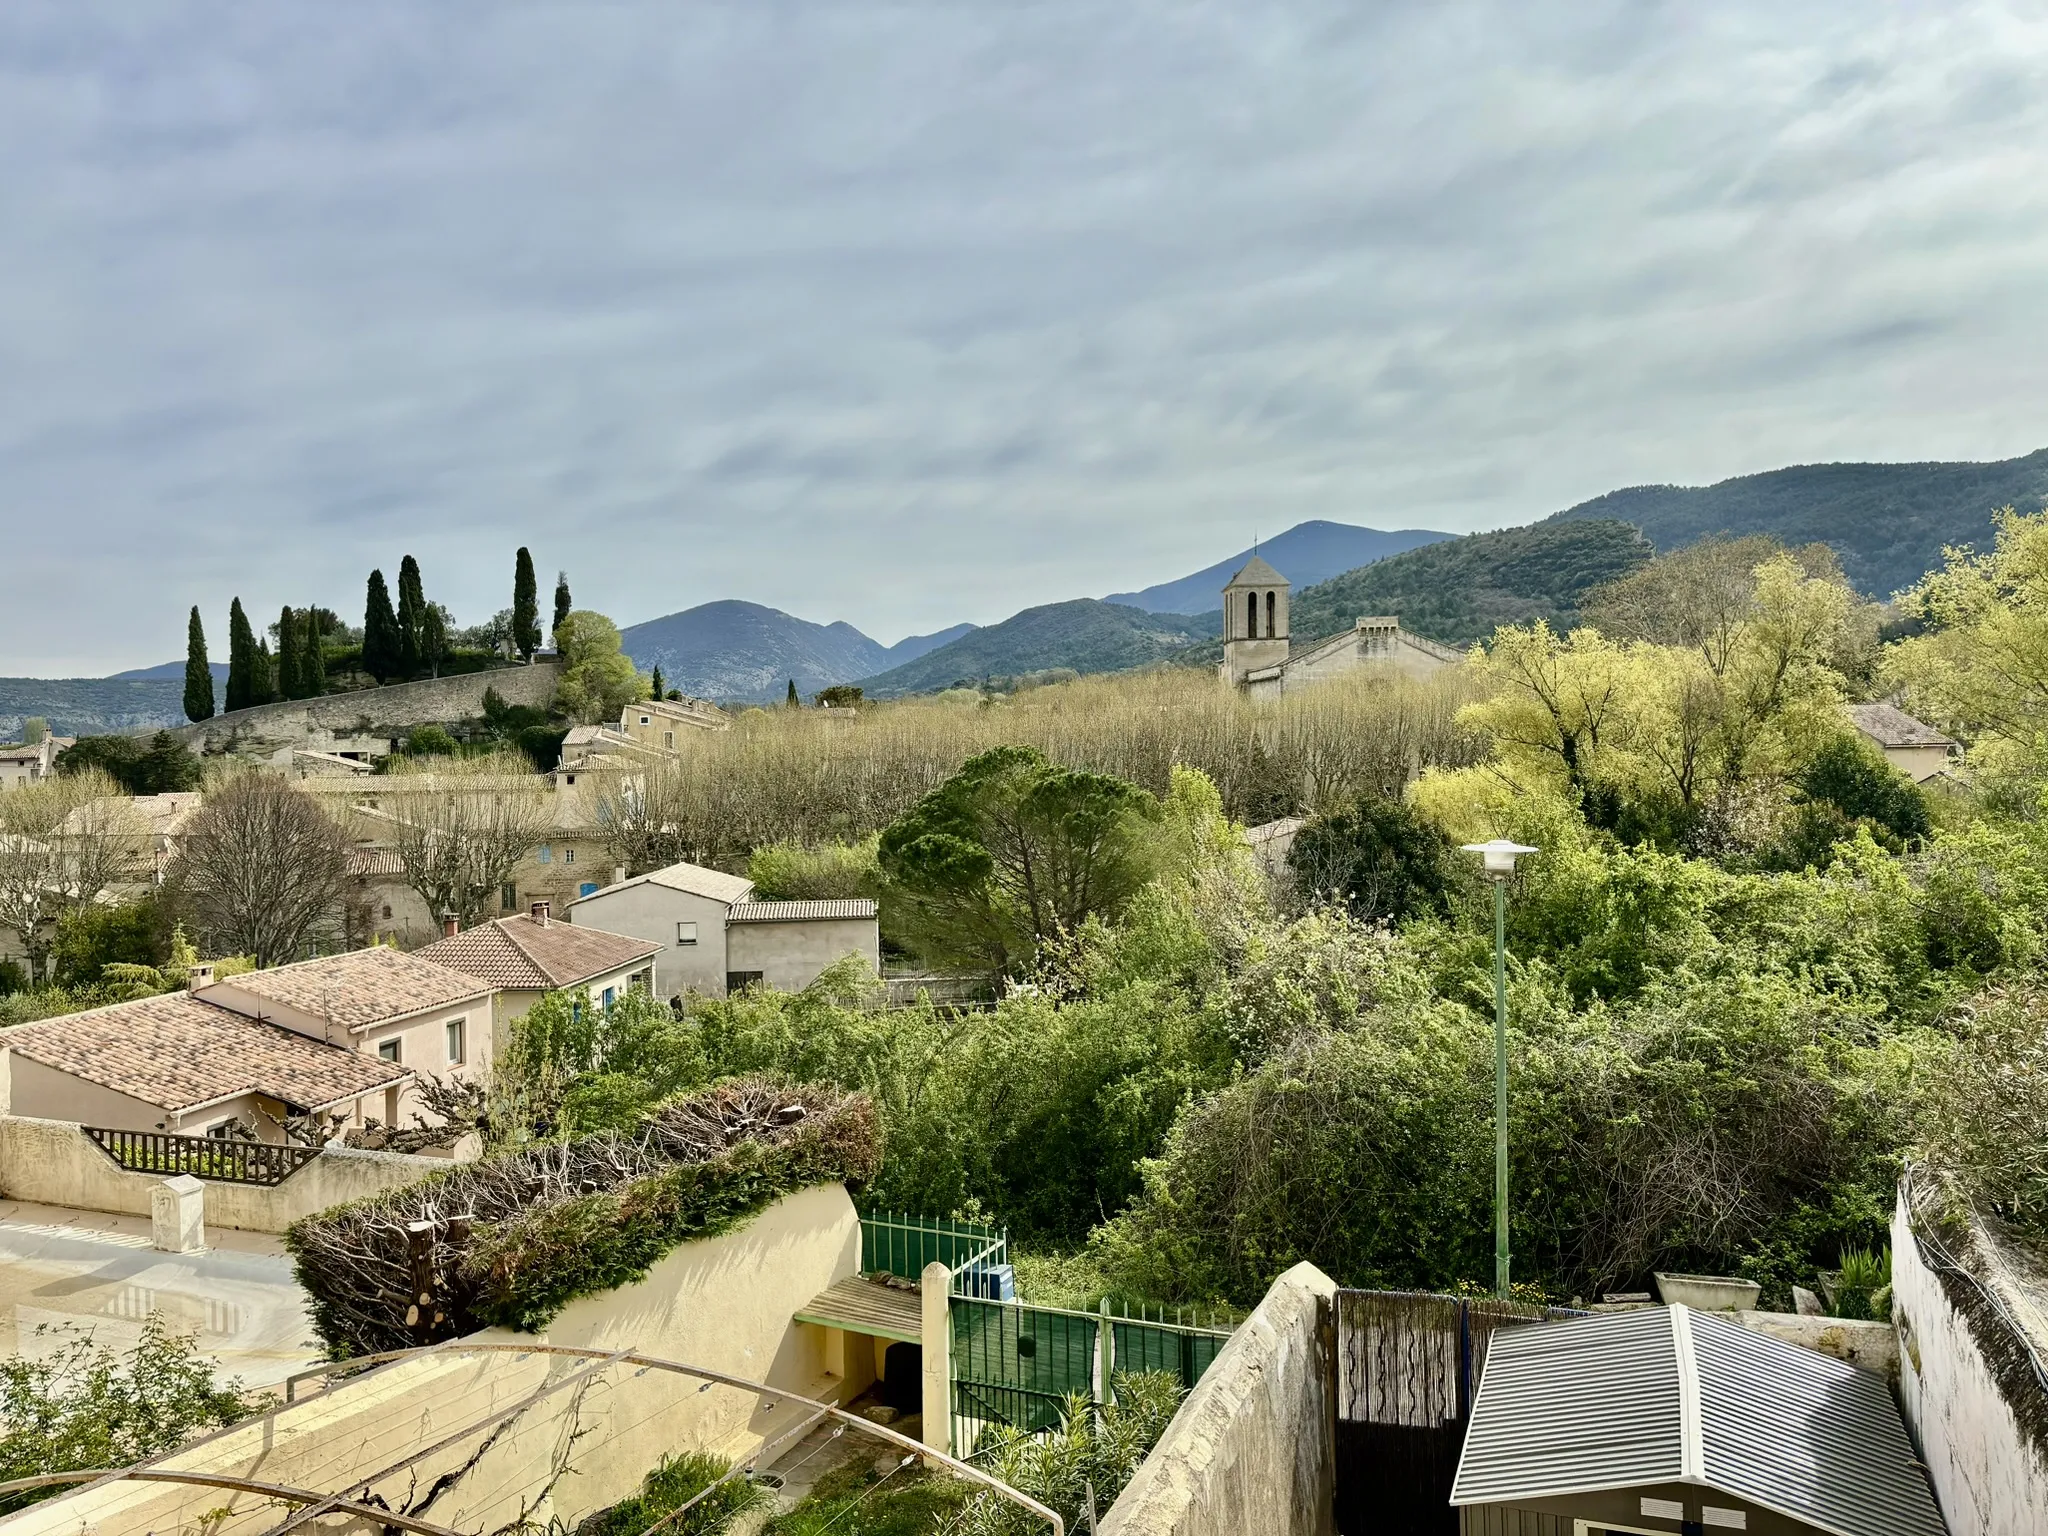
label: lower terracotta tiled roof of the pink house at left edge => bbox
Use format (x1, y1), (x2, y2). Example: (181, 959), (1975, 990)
(0, 991), (412, 1110)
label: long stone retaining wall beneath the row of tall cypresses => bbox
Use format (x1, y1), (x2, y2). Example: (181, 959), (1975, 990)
(172, 662), (561, 756)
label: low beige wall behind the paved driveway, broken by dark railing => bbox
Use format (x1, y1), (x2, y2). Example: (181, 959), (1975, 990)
(0, 1114), (449, 1233)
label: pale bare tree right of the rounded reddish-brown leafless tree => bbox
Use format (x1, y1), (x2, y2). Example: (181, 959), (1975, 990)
(358, 752), (555, 928)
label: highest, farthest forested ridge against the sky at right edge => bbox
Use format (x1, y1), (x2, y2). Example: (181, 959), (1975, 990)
(1538, 449), (2048, 598)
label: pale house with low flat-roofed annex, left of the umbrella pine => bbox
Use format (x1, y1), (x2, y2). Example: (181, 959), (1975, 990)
(569, 864), (881, 997)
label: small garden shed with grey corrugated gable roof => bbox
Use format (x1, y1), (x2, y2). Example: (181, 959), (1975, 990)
(1450, 1307), (1946, 1536)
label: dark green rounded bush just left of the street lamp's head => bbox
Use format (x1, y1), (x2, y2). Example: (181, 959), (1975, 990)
(1286, 795), (1460, 924)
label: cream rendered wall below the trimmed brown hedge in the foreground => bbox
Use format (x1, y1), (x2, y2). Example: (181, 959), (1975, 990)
(0, 1186), (860, 1536)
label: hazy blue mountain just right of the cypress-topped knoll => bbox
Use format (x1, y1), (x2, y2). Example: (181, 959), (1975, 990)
(621, 600), (973, 700)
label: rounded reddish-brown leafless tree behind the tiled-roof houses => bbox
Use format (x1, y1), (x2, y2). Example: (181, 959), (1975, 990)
(168, 774), (348, 965)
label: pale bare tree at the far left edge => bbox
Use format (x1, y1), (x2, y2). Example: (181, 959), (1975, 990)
(0, 768), (150, 981)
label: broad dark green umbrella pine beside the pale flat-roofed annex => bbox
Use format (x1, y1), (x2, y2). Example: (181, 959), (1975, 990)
(881, 748), (1159, 973)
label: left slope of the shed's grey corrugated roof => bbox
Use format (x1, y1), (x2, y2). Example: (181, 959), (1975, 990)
(1450, 1309), (1683, 1503)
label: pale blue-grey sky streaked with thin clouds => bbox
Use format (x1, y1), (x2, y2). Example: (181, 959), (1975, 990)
(0, 0), (2048, 676)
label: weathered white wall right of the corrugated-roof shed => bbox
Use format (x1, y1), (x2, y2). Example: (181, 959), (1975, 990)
(1892, 1200), (2048, 1536)
